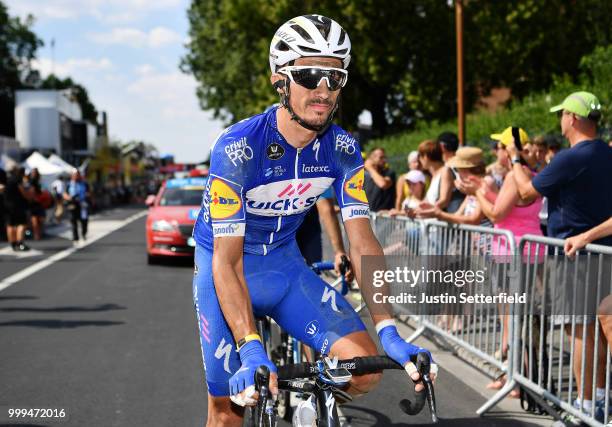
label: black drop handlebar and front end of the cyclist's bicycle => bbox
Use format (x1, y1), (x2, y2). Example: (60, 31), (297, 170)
(253, 353), (438, 427)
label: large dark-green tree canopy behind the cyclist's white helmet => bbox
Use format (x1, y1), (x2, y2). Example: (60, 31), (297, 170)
(181, 0), (612, 136)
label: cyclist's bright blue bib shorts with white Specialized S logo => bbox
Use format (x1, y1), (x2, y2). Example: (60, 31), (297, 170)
(193, 242), (366, 396)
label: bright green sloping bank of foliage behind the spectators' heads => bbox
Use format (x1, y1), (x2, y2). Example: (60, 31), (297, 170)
(369, 44), (612, 170)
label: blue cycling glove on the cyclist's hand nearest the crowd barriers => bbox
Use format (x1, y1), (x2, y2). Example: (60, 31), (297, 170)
(376, 321), (438, 376)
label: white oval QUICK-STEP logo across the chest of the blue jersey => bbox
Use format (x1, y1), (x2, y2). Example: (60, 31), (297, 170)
(245, 177), (334, 216)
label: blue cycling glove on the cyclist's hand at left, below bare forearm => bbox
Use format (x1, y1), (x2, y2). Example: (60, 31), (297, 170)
(229, 340), (276, 406)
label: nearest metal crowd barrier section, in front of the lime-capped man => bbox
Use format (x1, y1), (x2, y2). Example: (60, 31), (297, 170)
(506, 235), (612, 426)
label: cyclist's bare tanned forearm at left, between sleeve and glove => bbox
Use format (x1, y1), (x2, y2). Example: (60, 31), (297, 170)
(212, 237), (257, 342)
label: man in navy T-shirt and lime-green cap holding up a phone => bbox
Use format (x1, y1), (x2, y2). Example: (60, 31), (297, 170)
(508, 92), (612, 411)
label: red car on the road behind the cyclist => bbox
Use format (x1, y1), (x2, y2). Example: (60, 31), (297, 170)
(146, 177), (208, 264)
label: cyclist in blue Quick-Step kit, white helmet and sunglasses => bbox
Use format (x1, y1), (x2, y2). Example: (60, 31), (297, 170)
(193, 15), (436, 426)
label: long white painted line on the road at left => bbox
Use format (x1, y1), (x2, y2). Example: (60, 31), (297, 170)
(0, 210), (148, 292)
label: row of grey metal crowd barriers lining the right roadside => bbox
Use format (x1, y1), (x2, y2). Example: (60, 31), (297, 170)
(372, 214), (612, 426)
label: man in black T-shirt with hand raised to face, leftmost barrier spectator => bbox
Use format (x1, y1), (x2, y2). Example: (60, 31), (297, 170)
(364, 147), (395, 212)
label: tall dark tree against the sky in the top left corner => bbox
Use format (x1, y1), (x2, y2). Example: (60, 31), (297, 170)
(0, 1), (43, 136)
